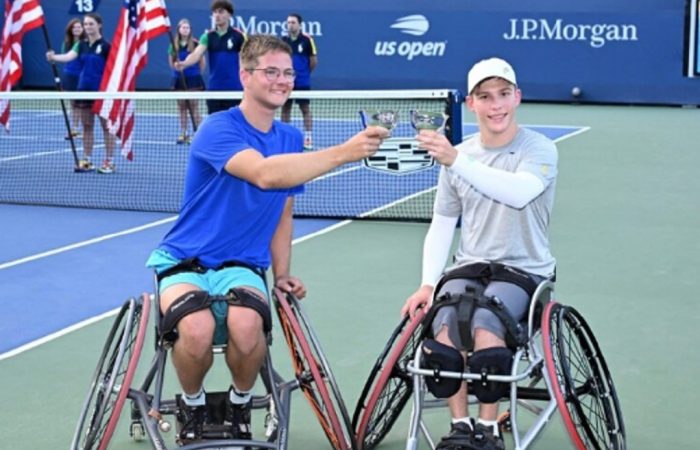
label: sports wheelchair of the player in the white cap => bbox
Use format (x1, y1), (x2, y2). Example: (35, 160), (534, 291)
(352, 270), (626, 450)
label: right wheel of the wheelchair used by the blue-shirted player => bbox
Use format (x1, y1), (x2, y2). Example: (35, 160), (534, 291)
(274, 289), (356, 450)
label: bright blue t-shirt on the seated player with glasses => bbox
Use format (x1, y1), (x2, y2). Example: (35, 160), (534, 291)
(159, 108), (304, 269)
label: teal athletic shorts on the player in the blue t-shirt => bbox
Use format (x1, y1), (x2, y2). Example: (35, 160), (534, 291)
(146, 250), (267, 345)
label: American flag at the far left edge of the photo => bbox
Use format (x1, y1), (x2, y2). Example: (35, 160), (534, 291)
(0, 0), (44, 130)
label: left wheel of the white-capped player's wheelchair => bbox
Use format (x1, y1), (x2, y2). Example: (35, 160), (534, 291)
(352, 309), (425, 450)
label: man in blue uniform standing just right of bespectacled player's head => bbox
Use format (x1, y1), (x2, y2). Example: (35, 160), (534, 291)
(282, 13), (318, 150)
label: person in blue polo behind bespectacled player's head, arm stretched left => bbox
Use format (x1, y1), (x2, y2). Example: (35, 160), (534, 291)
(174, 0), (246, 114)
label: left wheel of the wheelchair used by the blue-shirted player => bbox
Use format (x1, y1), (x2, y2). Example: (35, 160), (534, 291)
(71, 294), (150, 450)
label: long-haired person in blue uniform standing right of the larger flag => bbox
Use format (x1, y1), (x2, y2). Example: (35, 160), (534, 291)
(168, 19), (206, 144)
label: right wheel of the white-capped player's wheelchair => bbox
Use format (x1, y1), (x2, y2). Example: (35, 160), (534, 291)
(542, 302), (626, 450)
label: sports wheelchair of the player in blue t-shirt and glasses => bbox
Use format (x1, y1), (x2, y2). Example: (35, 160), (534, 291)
(71, 274), (356, 450)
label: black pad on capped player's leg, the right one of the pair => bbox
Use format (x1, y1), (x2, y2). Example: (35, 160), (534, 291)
(467, 347), (513, 403)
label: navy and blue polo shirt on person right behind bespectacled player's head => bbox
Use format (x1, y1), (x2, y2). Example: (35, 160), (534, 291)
(199, 27), (246, 91)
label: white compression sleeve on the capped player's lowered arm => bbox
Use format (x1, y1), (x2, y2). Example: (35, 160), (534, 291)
(421, 214), (459, 286)
